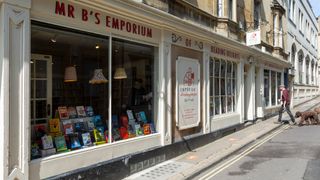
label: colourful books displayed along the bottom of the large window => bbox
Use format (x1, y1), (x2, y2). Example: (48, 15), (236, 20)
(31, 106), (156, 159)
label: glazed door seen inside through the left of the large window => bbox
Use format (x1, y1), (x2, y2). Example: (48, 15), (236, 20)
(30, 54), (52, 127)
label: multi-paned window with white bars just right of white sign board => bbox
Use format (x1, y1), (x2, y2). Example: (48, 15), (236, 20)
(209, 58), (236, 116)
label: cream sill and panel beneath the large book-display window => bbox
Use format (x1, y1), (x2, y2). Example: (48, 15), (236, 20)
(30, 133), (161, 179)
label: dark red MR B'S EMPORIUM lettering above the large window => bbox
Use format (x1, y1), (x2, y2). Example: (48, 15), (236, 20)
(55, 1), (152, 38)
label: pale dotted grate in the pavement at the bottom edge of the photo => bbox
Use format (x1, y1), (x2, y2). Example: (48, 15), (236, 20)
(125, 161), (191, 180)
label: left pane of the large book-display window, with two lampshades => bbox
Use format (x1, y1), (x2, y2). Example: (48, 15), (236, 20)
(31, 26), (112, 159)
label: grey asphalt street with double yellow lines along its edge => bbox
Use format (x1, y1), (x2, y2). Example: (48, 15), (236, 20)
(192, 125), (320, 180)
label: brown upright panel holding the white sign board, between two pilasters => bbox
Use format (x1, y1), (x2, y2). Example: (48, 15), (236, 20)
(171, 45), (203, 142)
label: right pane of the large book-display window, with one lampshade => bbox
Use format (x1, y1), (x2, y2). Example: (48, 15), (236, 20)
(112, 39), (155, 140)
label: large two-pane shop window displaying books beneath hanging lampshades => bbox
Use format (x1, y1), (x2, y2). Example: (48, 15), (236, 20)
(30, 25), (156, 159)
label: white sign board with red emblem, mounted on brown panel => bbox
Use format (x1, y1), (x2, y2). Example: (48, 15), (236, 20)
(176, 57), (200, 130)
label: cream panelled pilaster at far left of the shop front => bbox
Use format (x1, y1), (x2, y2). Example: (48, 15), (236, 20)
(0, 0), (31, 179)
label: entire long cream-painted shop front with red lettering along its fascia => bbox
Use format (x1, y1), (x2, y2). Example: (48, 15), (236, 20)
(0, 0), (289, 179)
